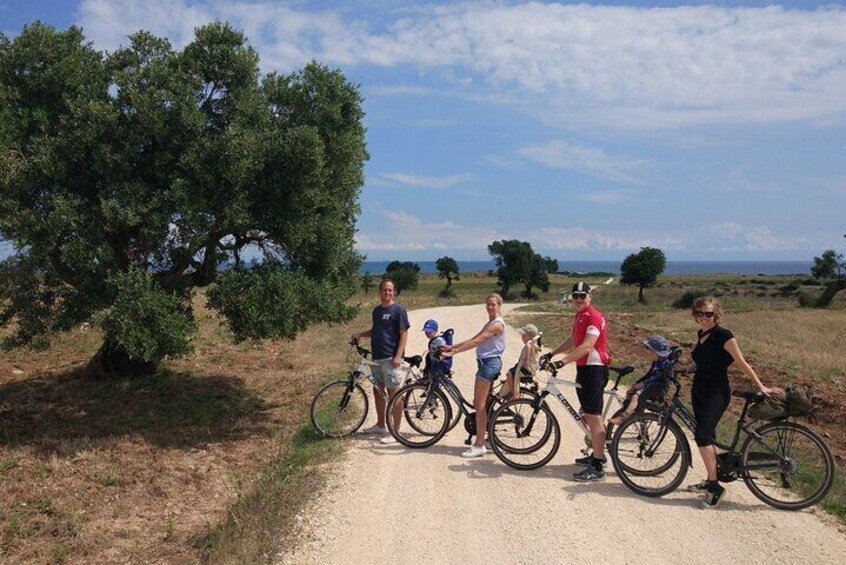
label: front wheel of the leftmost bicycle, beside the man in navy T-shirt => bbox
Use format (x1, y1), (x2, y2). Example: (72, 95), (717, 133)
(309, 379), (369, 437)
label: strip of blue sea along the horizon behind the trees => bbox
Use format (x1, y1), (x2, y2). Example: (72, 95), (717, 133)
(359, 261), (813, 276)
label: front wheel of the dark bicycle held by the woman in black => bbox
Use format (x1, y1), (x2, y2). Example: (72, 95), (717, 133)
(611, 412), (691, 497)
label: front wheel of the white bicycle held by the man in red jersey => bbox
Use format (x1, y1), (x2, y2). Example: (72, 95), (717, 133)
(489, 398), (561, 471)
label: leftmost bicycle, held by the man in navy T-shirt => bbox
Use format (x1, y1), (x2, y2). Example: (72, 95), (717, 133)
(309, 343), (423, 438)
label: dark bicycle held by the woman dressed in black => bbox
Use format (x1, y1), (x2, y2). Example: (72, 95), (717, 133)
(611, 370), (835, 510)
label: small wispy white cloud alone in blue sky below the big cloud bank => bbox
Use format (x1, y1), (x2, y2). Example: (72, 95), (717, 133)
(517, 141), (646, 182)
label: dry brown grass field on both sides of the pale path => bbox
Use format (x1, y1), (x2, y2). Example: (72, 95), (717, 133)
(0, 273), (846, 563)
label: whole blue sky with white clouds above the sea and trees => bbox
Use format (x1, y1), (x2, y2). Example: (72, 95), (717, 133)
(0, 0), (846, 260)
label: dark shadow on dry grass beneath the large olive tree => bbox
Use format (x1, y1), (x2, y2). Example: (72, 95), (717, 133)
(0, 369), (273, 452)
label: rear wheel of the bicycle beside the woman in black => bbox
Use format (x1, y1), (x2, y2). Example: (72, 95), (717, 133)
(741, 422), (834, 510)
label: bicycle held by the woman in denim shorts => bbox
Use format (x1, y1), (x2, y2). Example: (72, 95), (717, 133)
(388, 356), (538, 449)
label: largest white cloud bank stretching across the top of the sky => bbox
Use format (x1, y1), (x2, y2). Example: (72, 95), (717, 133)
(78, 0), (846, 130)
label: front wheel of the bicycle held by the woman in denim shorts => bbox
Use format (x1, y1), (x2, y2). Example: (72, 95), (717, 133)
(387, 383), (452, 449)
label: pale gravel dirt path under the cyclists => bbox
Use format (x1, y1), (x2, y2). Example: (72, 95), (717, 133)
(280, 305), (846, 565)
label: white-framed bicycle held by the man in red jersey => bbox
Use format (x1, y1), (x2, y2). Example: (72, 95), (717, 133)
(490, 361), (634, 471)
